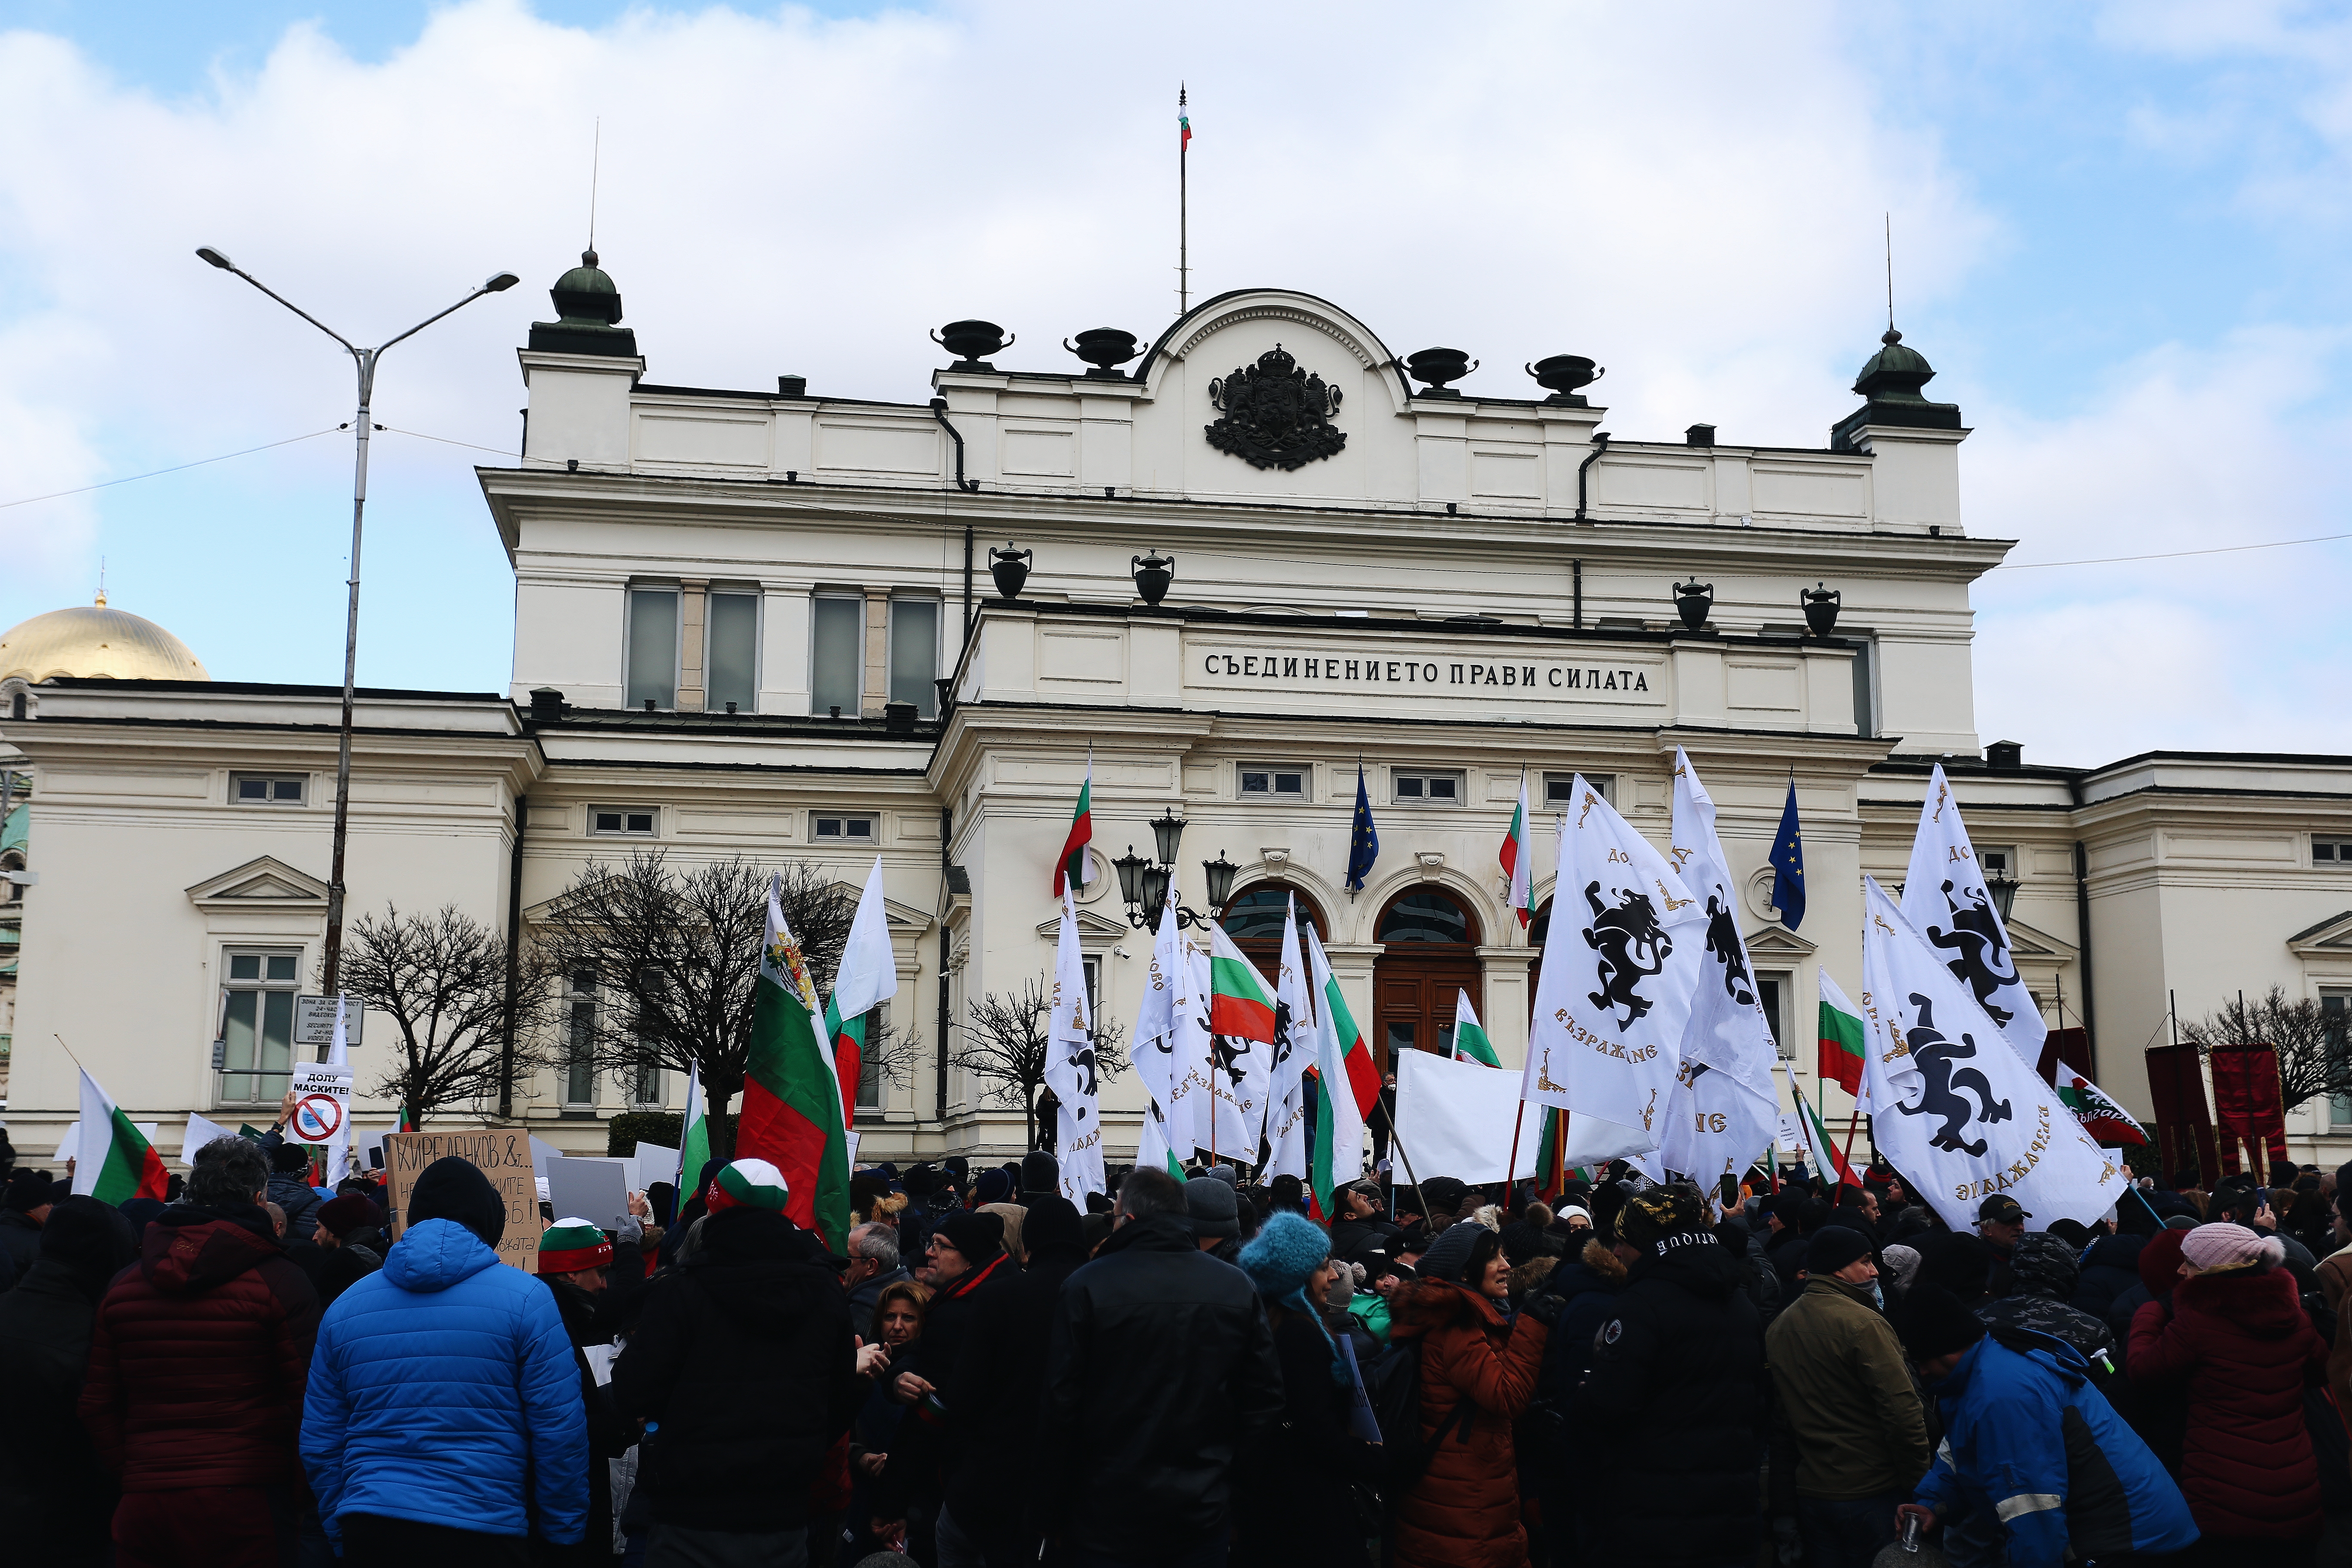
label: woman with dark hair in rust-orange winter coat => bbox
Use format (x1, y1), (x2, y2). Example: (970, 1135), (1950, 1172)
(1387, 1220), (1559, 1568)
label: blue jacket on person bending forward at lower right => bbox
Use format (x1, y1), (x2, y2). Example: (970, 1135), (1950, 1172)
(1917, 1331), (2197, 1568)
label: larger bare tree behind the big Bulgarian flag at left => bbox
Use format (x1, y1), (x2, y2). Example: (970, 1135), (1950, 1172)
(536, 848), (889, 1154)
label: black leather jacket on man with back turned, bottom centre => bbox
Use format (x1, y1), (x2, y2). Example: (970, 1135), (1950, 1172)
(1032, 1216), (1282, 1561)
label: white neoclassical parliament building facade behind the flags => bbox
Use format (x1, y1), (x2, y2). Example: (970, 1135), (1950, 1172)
(0, 263), (2352, 1161)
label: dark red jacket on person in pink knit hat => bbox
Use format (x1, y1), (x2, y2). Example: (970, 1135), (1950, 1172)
(2124, 1269), (2328, 1540)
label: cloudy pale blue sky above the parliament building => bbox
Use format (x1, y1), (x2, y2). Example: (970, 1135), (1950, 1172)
(0, 0), (2352, 762)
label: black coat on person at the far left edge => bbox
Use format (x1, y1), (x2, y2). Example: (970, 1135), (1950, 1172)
(0, 1260), (115, 1568)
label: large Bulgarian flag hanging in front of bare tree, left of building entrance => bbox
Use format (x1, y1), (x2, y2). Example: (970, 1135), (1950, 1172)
(734, 879), (849, 1253)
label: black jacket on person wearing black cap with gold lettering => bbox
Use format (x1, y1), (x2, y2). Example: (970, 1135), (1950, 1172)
(1569, 1232), (1769, 1568)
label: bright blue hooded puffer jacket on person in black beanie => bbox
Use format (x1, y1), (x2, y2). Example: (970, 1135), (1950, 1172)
(301, 1220), (588, 1544)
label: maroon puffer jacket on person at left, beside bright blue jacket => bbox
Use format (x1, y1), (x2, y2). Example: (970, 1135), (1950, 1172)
(80, 1206), (318, 1493)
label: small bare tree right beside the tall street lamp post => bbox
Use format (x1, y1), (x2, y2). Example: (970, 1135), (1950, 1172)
(341, 905), (546, 1124)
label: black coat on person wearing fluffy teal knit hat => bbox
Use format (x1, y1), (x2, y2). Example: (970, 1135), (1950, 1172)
(1232, 1312), (1378, 1568)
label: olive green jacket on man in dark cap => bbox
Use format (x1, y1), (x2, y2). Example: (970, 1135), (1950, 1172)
(1764, 1279), (1929, 1498)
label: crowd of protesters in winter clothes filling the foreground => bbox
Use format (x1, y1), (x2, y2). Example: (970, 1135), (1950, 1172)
(14, 1100), (2352, 1568)
